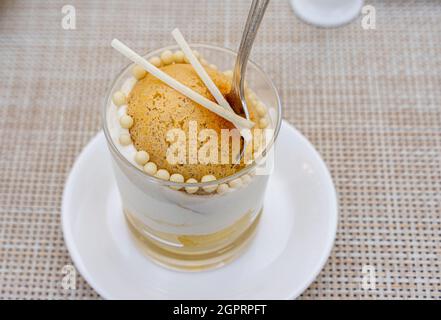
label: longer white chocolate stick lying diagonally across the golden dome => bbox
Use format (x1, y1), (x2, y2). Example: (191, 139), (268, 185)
(111, 39), (254, 129)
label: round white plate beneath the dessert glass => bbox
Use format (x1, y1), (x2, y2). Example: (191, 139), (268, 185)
(62, 122), (338, 299)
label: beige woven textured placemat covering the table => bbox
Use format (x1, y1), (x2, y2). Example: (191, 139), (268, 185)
(0, 0), (441, 299)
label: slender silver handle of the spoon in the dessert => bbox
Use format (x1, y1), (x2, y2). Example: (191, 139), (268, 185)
(232, 0), (269, 112)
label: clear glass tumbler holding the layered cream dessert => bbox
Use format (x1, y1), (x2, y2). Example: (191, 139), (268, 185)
(103, 44), (281, 271)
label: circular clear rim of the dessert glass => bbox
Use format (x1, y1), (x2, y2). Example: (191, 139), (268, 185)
(101, 43), (282, 188)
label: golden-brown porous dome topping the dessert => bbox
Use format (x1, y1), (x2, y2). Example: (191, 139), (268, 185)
(127, 64), (246, 181)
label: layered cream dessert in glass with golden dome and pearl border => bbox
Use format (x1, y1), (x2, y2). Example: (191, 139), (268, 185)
(103, 35), (281, 270)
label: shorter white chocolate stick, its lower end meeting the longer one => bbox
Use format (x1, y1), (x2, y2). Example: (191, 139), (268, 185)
(172, 28), (233, 112)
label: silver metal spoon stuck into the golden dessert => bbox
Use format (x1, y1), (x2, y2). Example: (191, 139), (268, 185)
(226, 0), (269, 120)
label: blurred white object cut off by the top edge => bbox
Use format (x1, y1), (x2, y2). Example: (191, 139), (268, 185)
(289, 0), (363, 28)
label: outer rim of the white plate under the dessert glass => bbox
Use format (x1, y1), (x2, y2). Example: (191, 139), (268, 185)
(61, 120), (339, 300)
